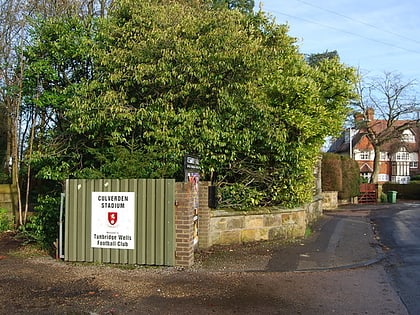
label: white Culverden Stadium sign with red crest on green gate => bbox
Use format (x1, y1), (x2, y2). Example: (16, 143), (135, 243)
(91, 192), (135, 249)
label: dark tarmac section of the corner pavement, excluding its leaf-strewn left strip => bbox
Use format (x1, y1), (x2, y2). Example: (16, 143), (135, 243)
(268, 210), (384, 271)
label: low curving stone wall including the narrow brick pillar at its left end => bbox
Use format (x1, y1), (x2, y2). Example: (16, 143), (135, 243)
(198, 183), (322, 249)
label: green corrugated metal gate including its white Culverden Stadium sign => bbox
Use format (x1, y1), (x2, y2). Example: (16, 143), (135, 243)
(64, 179), (175, 266)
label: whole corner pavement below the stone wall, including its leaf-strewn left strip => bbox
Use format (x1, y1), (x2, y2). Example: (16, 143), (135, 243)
(196, 205), (388, 272)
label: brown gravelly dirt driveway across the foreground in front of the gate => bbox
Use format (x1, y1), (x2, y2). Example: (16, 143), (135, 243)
(0, 235), (406, 315)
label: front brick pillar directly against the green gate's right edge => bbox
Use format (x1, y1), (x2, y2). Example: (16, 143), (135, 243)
(175, 183), (194, 267)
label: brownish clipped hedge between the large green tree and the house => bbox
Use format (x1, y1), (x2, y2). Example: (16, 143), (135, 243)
(321, 153), (360, 199)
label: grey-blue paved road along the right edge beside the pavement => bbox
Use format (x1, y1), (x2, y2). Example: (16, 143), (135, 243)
(371, 202), (420, 314)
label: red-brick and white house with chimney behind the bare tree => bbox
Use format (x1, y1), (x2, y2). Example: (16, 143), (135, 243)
(328, 109), (420, 184)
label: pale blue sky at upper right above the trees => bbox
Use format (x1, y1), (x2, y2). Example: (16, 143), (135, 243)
(255, 0), (420, 82)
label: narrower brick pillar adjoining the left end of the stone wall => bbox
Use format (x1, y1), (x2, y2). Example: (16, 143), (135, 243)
(198, 182), (212, 249)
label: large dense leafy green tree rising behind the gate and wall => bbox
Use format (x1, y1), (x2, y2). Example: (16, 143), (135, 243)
(24, 0), (356, 210)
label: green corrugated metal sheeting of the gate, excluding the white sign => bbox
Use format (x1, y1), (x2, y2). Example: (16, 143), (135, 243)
(64, 179), (175, 266)
